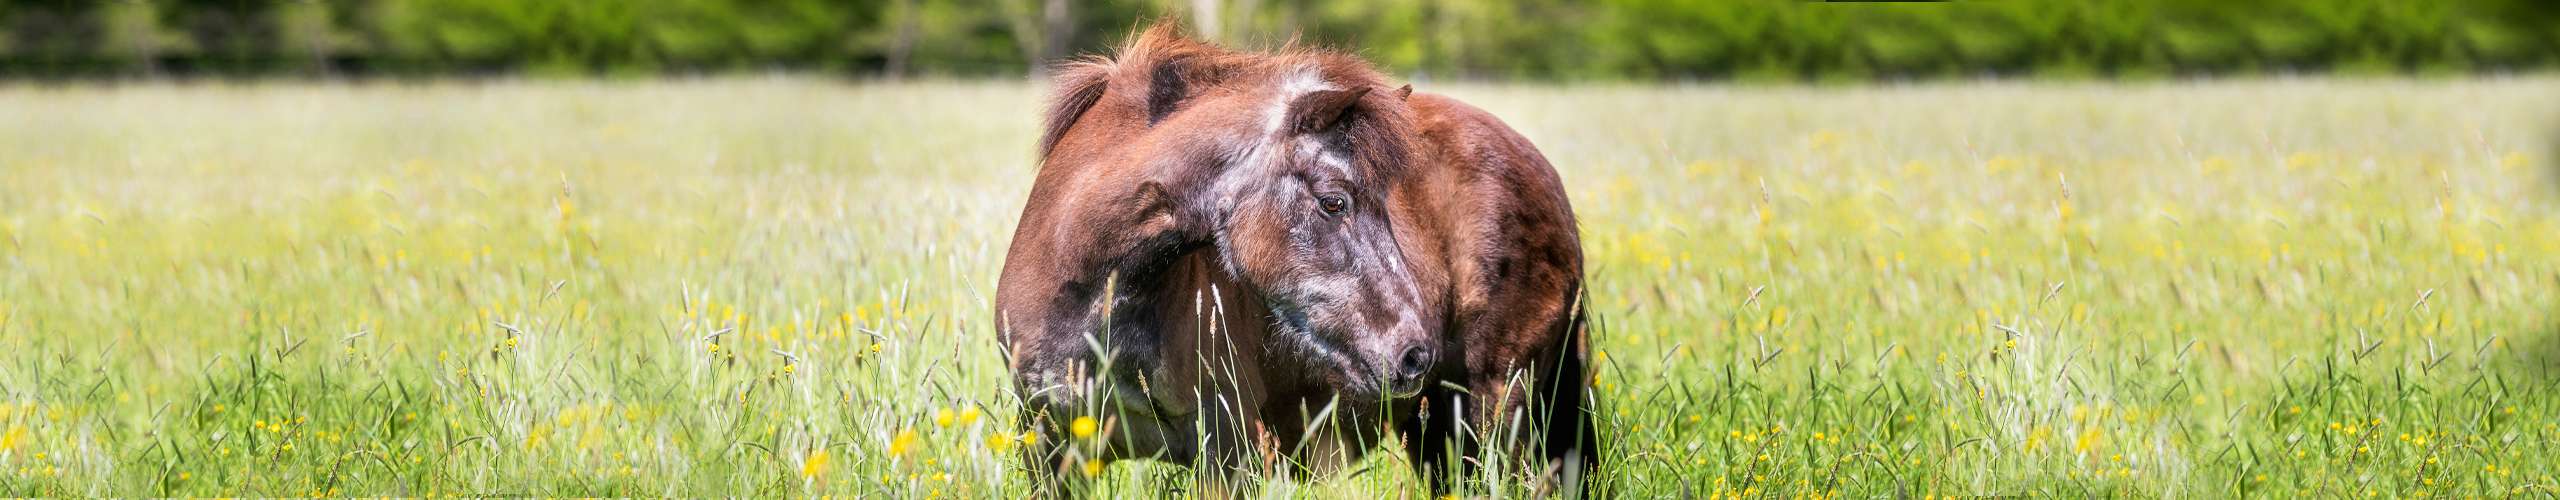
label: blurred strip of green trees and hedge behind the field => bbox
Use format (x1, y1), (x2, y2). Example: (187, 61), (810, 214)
(0, 0), (2560, 82)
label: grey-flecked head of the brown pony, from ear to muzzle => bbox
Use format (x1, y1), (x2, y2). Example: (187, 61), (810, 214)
(1203, 69), (1423, 392)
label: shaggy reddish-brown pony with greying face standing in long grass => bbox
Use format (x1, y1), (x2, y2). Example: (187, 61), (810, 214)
(996, 23), (1597, 492)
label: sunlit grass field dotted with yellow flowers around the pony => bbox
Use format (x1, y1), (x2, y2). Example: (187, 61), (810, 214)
(0, 77), (2560, 497)
